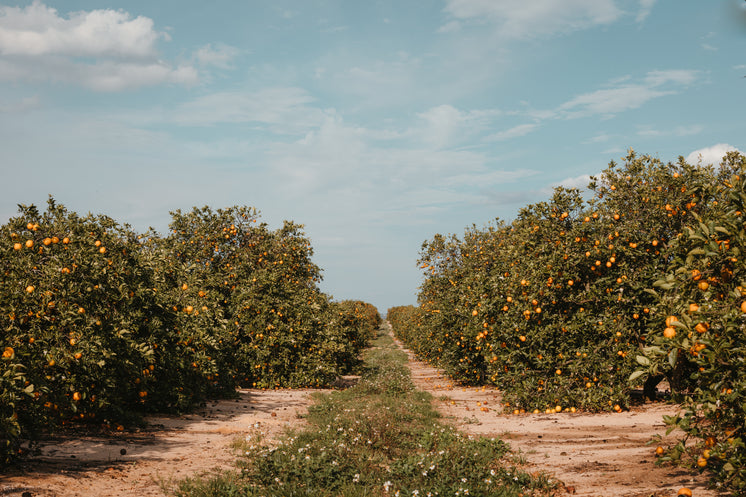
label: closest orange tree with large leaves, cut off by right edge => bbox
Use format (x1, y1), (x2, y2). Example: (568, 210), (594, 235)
(633, 153), (746, 493)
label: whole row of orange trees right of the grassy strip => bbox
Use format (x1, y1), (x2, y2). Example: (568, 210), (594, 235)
(388, 152), (746, 488)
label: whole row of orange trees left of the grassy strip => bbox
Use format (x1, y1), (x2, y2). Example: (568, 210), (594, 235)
(0, 198), (380, 461)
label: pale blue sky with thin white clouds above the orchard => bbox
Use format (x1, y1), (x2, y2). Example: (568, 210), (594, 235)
(0, 0), (746, 313)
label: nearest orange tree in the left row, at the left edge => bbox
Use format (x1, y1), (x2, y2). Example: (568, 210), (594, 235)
(0, 199), (163, 454)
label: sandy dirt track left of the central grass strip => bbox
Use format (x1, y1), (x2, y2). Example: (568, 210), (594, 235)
(0, 390), (310, 497)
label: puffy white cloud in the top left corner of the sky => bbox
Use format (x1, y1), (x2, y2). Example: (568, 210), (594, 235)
(0, 0), (199, 92)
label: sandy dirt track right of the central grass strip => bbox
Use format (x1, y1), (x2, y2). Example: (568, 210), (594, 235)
(390, 322), (724, 497)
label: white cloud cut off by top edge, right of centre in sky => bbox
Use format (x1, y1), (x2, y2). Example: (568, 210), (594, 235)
(441, 0), (622, 39)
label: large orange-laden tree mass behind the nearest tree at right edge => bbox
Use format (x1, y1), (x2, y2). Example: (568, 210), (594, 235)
(392, 152), (708, 410)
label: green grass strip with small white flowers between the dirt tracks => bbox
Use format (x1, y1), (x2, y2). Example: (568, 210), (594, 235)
(174, 328), (556, 497)
